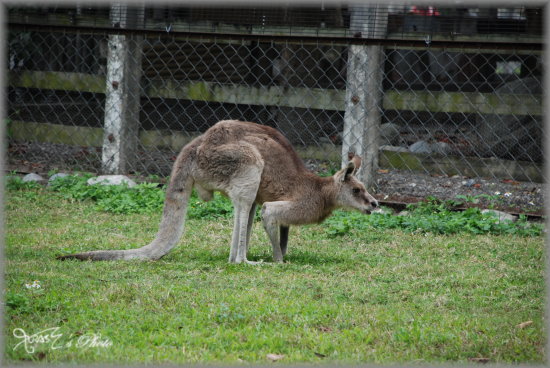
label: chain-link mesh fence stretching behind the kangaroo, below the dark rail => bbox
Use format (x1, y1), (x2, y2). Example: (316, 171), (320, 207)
(6, 7), (543, 196)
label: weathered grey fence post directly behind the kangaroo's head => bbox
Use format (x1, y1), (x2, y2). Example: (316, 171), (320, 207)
(342, 5), (388, 189)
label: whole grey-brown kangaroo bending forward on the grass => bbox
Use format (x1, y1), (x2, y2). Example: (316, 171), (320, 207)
(58, 120), (378, 264)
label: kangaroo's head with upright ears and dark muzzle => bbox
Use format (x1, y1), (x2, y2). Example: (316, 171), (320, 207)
(333, 153), (378, 214)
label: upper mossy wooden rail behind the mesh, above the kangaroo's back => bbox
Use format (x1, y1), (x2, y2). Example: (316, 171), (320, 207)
(8, 71), (542, 116)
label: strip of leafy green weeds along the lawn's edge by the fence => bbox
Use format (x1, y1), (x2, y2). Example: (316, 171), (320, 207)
(8, 175), (542, 237)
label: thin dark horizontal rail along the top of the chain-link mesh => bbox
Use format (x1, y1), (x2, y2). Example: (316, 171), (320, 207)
(8, 22), (544, 51)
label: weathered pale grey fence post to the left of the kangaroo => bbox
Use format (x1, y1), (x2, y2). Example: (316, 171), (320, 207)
(102, 3), (144, 174)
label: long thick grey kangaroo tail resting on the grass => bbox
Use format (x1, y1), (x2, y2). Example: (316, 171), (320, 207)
(57, 139), (198, 261)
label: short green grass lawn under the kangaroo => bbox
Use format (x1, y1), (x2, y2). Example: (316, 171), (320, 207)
(4, 185), (546, 364)
